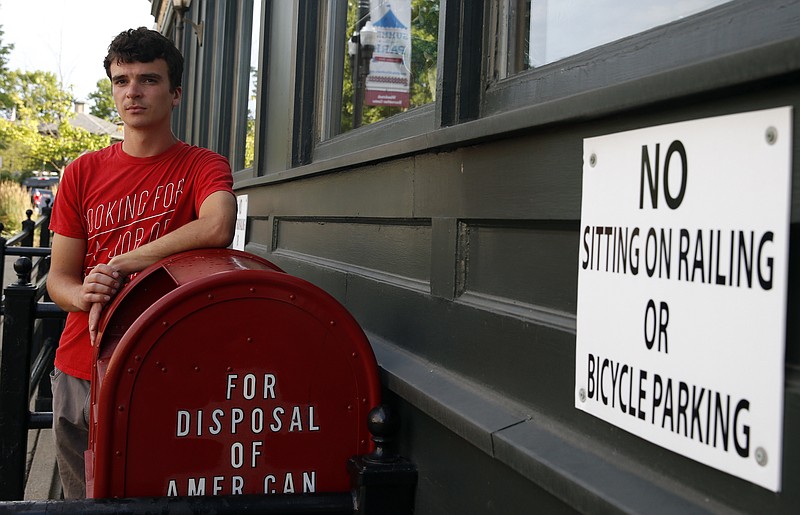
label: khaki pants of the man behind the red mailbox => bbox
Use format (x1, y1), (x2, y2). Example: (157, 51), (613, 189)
(50, 368), (90, 499)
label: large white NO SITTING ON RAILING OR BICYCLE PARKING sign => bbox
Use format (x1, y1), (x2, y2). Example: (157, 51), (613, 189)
(575, 107), (792, 491)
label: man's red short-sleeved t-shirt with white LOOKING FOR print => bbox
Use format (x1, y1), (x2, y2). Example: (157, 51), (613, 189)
(50, 142), (233, 379)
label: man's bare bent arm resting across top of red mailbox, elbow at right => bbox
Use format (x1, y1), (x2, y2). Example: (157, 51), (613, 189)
(108, 191), (236, 275)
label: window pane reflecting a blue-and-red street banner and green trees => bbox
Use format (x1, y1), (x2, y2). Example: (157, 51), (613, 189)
(341, 0), (439, 132)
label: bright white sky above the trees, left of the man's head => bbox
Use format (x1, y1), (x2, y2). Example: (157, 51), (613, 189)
(0, 0), (155, 100)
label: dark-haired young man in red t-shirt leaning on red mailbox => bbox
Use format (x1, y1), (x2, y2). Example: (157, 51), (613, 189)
(47, 27), (236, 498)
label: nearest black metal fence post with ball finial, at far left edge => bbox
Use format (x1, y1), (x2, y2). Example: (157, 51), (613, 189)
(0, 258), (36, 501)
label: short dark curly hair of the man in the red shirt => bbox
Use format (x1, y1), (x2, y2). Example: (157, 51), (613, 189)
(103, 27), (183, 91)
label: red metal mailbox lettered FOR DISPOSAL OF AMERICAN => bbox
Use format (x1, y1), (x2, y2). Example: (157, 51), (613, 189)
(86, 249), (380, 497)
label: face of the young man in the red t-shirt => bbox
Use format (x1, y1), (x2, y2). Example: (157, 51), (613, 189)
(110, 59), (181, 129)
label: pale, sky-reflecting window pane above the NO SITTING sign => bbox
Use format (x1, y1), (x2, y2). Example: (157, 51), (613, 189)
(498, 0), (730, 77)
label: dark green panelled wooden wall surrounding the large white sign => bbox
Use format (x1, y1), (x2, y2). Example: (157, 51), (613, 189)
(162, 0), (800, 514)
